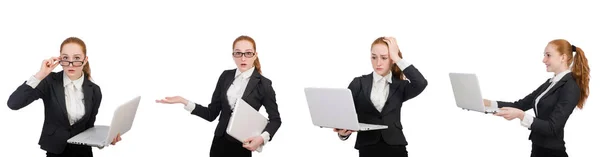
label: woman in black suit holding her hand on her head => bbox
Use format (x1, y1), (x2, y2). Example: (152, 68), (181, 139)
(334, 37), (427, 157)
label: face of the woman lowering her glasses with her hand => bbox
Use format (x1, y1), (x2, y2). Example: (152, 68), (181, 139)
(60, 43), (87, 78)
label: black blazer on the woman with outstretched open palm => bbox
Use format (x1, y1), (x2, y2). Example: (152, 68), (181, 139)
(192, 69), (281, 141)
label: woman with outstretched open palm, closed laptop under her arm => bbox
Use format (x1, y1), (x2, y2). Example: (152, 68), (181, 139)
(156, 36), (281, 157)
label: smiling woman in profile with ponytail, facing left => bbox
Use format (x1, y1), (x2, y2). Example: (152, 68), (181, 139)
(484, 39), (590, 157)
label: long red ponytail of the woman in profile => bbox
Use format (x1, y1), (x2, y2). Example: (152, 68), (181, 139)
(572, 46), (590, 109)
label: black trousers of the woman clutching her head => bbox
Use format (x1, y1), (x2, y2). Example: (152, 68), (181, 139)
(358, 140), (408, 157)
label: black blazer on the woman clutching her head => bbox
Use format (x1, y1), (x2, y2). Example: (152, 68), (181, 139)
(348, 65), (427, 149)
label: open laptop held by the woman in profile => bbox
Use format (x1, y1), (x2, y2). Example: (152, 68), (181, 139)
(449, 73), (498, 114)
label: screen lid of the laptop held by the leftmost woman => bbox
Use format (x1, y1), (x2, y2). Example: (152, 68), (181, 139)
(105, 96), (141, 145)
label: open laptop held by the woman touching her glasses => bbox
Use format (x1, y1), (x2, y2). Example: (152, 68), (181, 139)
(67, 96), (141, 148)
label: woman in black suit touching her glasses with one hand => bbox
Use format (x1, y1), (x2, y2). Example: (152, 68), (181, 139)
(8, 37), (121, 157)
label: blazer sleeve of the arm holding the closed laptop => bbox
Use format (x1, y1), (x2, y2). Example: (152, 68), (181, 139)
(261, 81), (281, 141)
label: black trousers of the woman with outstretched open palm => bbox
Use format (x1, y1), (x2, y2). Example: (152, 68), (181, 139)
(210, 134), (252, 157)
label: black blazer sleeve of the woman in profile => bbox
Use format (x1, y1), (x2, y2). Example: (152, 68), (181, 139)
(530, 81), (580, 137)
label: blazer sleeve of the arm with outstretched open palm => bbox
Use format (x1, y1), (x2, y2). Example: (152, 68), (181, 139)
(186, 71), (226, 122)
